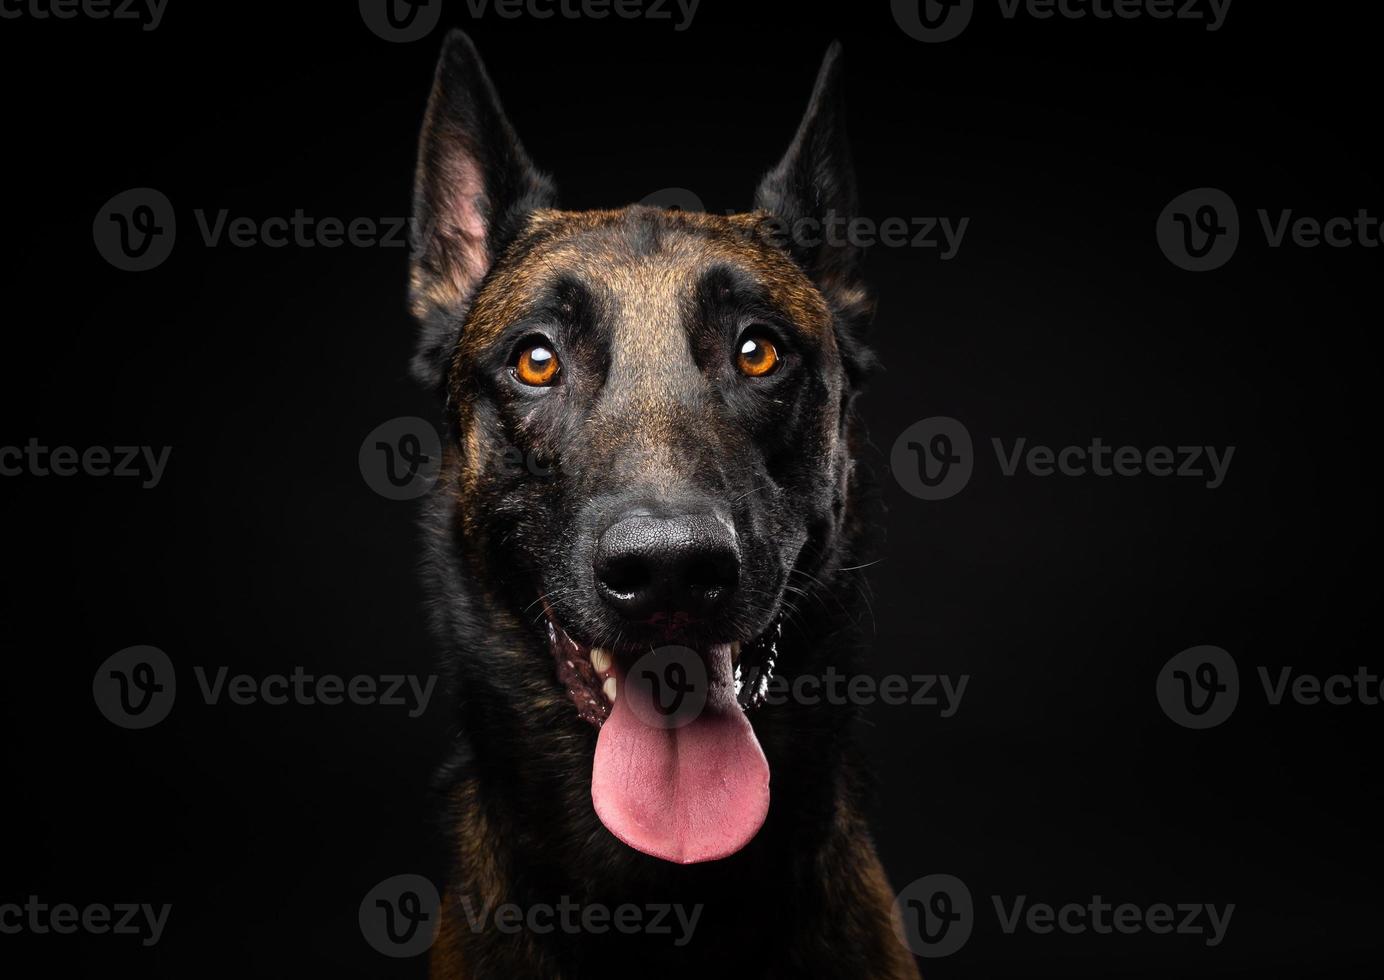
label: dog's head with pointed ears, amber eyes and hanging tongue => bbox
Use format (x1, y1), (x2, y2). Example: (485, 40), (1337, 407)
(412, 35), (868, 862)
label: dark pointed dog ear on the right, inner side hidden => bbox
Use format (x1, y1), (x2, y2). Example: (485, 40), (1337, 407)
(754, 42), (872, 367)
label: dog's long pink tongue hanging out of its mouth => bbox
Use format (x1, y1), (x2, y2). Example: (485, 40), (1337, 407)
(591, 646), (770, 864)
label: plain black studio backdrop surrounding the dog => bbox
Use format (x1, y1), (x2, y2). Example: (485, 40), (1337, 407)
(0, 0), (1384, 979)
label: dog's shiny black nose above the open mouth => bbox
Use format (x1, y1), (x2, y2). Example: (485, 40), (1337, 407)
(592, 514), (740, 620)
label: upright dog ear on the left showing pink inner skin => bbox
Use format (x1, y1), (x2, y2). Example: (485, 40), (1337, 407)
(408, 30), (556, 388)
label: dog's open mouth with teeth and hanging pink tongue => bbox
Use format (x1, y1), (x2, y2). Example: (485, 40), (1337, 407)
(548, 615), (781, 864)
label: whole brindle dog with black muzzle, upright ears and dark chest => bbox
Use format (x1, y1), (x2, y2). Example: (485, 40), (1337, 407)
(410, 32), (918, 980)
